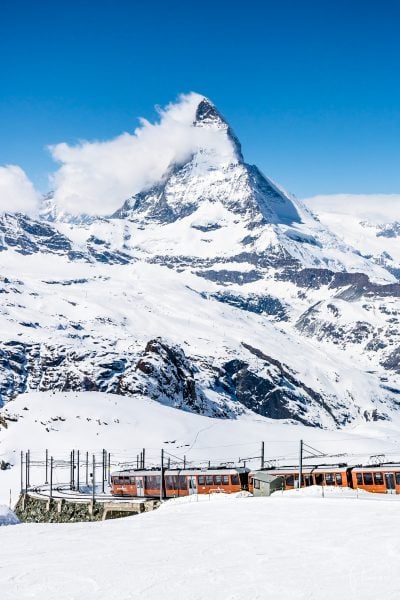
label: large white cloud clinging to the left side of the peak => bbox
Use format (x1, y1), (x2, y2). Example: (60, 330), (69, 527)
(50, 93), (238, 215)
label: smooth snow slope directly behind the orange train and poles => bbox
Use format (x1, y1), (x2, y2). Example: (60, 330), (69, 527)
(0, 392), (400, 503)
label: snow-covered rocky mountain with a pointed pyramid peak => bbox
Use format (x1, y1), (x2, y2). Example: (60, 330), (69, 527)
(0, 98), (400, 435)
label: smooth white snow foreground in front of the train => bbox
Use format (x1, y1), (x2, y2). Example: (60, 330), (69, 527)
(0, 495), (400, 600)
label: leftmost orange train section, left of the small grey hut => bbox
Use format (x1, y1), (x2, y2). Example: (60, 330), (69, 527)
(111, 467), (249, 498)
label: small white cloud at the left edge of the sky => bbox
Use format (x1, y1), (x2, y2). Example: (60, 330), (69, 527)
(0, 165), (39, 214)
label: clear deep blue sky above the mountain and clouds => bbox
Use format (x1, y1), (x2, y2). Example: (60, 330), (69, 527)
(0, 0), (400, 197)
